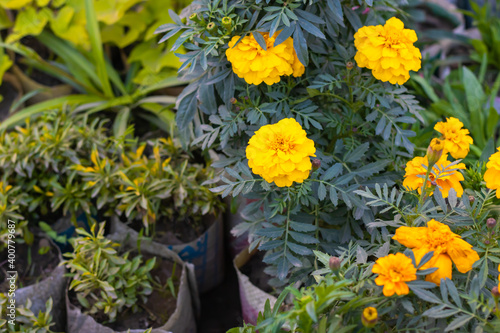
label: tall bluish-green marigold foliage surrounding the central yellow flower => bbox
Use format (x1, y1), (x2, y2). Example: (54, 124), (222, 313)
(158, 0), (421, 286)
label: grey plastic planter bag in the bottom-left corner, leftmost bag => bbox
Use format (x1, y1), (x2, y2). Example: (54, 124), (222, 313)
(1, 239), (67, 332)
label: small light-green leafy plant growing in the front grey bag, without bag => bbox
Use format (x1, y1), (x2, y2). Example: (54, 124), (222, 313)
(61, 223), (156, 322)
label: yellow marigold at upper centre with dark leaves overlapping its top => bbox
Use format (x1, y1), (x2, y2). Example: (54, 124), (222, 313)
(226, 32), (305, 85)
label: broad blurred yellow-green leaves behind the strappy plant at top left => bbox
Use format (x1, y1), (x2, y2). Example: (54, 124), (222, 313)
(0, 0), (185, 85)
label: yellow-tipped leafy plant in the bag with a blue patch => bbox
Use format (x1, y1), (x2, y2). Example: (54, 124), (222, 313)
(76, 134), (227, 291)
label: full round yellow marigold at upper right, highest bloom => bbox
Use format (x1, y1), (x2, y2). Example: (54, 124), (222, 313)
(354, 17), (422, 84)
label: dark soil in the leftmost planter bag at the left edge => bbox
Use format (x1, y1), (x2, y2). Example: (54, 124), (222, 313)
(0, 237), (59, 293)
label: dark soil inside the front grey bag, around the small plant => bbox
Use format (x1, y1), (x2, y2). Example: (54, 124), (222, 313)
(68, 253), (182, 332)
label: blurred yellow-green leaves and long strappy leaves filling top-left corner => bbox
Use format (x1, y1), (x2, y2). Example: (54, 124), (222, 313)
(0, 0), (189, 135)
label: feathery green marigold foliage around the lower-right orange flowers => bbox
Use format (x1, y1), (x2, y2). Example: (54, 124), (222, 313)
(229, 172), (500, 333)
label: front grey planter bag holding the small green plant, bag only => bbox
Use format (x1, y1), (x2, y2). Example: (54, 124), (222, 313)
(66, 226), (199, 333)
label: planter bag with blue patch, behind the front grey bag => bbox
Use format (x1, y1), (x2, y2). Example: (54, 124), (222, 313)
(111, 214), (224, 293)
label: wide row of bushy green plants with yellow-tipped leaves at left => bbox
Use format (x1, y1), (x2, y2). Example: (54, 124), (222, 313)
(0, 106), (222, 231)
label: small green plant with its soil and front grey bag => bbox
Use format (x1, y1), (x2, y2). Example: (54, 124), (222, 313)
(61, 223), (196, 333)
